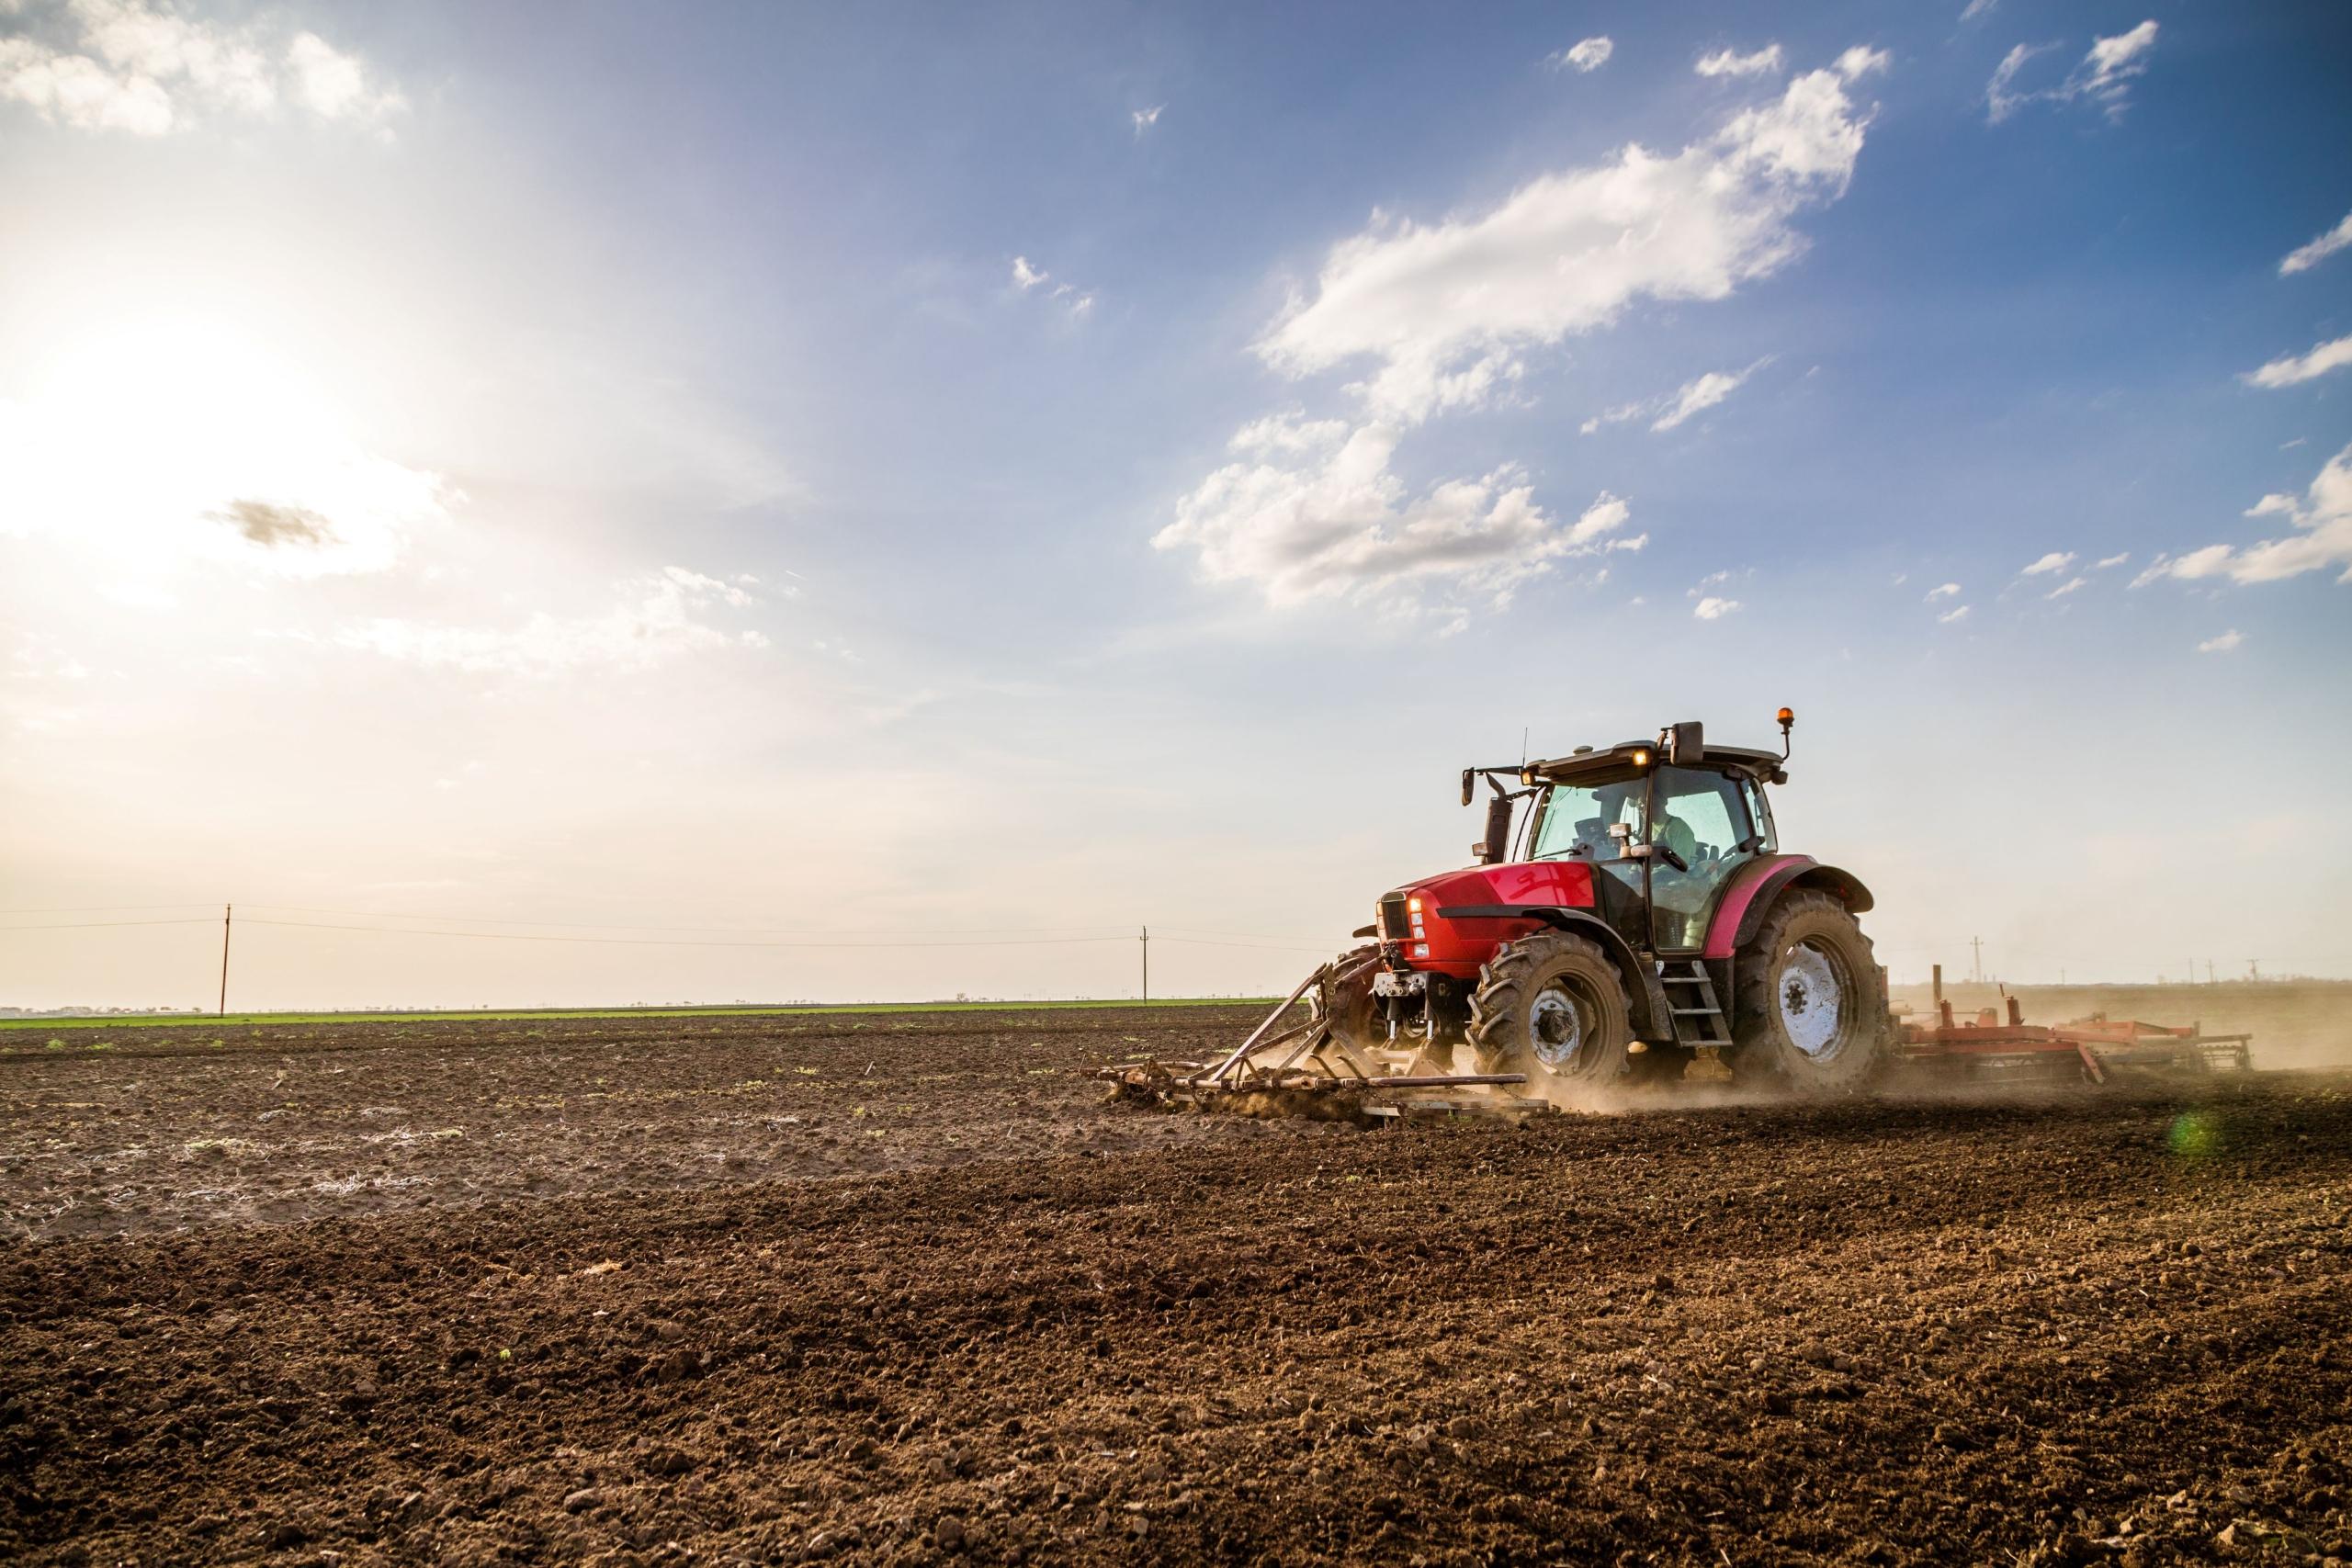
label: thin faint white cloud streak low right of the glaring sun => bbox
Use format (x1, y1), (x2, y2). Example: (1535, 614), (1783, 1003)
(336, 567), (767, 677)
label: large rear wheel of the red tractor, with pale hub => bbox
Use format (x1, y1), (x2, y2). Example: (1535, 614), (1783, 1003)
(1731, 888), (1886, 1093)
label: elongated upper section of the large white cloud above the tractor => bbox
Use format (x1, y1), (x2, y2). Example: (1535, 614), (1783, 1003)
(1256, 71), (1868, 423)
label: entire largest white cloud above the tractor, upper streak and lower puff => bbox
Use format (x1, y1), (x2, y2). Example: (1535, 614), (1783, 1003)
(1152, 49), (1868, 626)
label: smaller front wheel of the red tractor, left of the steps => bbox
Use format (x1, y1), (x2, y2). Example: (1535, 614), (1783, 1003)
(1470, 931), (1633, 1093)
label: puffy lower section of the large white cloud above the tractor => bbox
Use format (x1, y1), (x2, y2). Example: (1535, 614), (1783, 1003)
(1152, 416), (1646, 604)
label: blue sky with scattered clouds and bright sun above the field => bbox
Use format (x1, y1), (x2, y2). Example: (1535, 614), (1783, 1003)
(0, 0), (2352, 1009)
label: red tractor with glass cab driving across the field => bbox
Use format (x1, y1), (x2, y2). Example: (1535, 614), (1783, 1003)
(1303, 707), (1889, 1098)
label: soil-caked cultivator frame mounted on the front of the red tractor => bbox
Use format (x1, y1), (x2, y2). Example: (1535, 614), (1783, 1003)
(1096, 954), (1550, 1122)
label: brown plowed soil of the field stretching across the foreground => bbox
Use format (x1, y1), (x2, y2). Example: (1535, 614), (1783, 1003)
(0, 1009), (2352, 1565)
